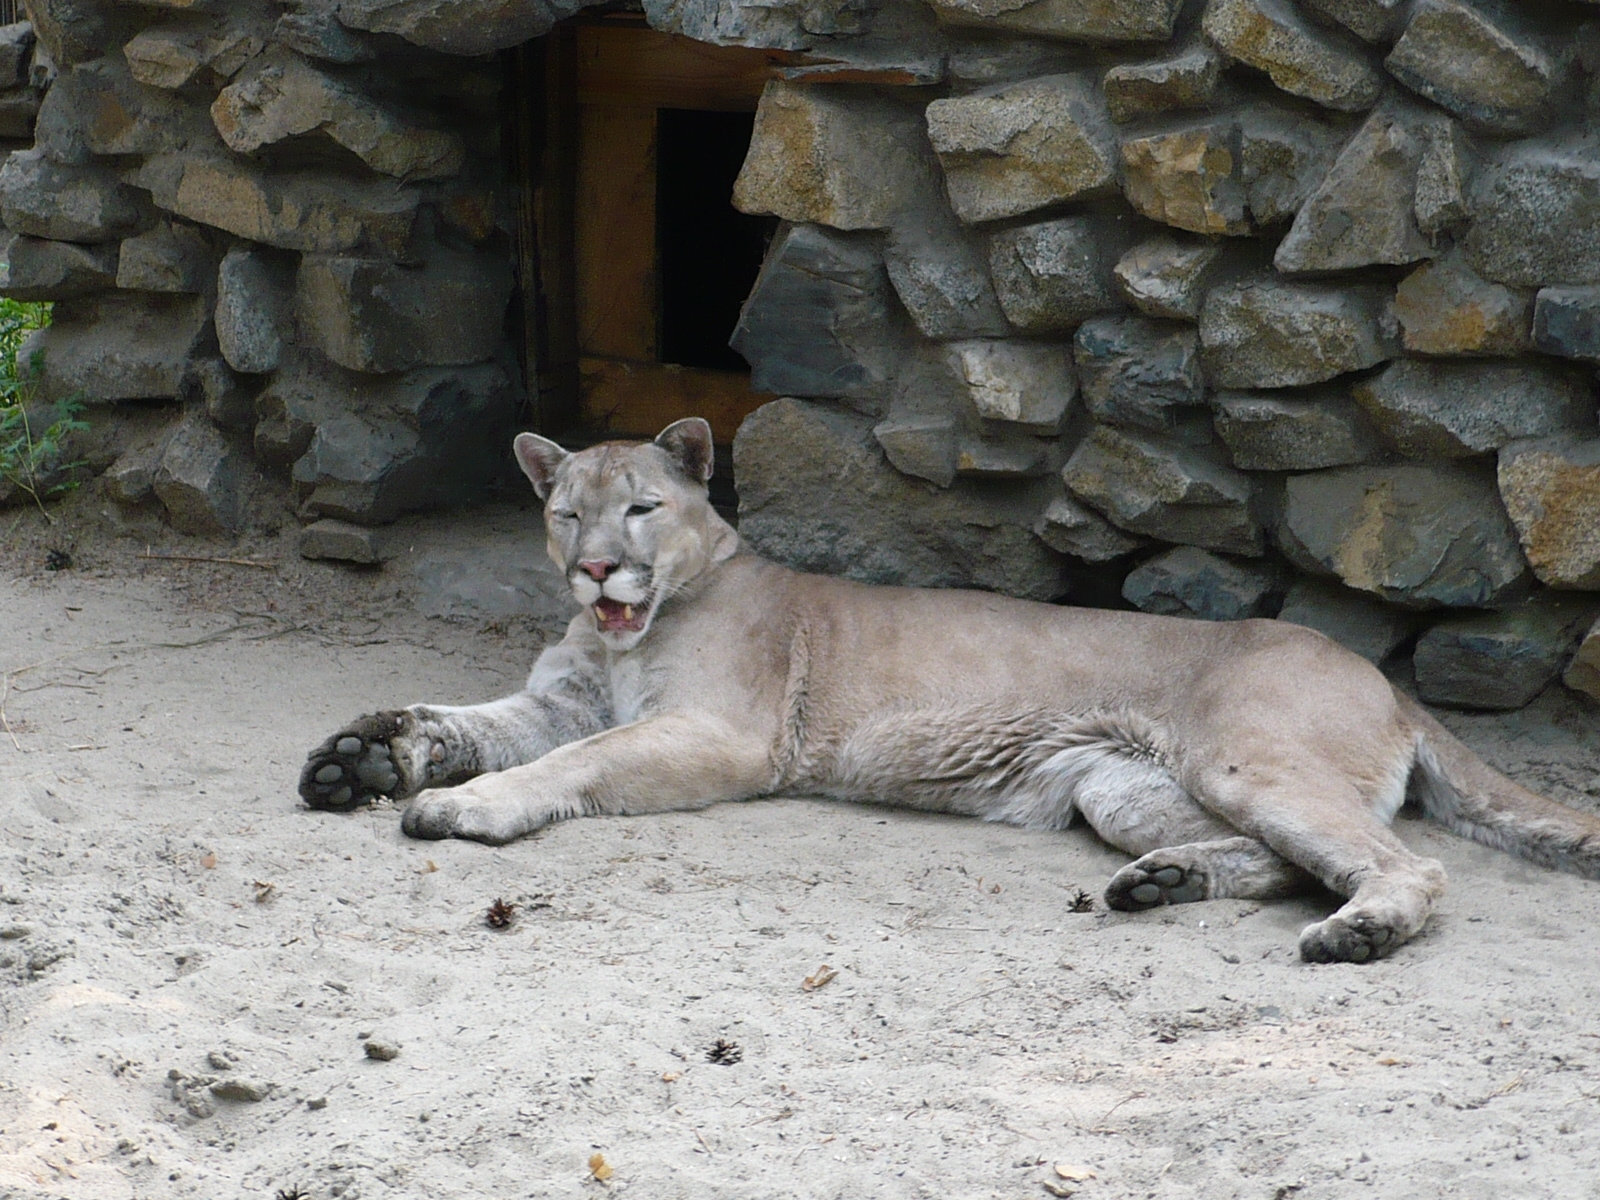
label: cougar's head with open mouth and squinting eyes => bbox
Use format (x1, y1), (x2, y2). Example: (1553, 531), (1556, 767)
(514, 416), (739, 651)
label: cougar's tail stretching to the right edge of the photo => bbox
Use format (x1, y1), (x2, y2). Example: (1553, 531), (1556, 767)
(1395, 688), (1600, 878)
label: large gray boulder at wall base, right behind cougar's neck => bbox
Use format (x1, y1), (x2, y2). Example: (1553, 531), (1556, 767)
(733, 400), (1067, 600)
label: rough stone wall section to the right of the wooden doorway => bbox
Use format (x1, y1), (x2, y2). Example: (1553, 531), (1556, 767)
(716, 0), (1600, 707)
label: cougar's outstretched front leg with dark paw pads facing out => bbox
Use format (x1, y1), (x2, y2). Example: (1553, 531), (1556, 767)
(299, 691), (605, 810)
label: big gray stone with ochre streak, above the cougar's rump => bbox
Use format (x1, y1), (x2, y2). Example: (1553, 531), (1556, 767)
(1278, 462), (1528, 608)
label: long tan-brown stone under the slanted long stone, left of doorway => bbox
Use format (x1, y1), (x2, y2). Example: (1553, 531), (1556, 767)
(143, 155), (419, 258)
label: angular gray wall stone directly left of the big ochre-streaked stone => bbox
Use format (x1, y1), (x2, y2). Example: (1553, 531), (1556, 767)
(1061, 426), (1262, 555)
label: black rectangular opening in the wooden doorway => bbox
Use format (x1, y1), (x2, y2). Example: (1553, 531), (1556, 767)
(656, 109), (778, 371)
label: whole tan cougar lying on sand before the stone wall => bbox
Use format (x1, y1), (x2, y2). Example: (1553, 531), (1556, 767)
(299, 419), (1600, 962)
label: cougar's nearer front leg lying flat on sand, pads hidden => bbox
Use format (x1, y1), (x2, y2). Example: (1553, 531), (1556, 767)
(402, 714), (773, 845)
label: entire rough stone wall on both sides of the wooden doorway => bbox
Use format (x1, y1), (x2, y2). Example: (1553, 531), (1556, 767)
(0, 0), (1600, 707)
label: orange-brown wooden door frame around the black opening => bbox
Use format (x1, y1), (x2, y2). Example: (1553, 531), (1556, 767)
(506, 16), (797, 445)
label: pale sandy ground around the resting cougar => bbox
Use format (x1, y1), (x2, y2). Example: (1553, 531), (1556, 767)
(0, 492), (1600, 1200)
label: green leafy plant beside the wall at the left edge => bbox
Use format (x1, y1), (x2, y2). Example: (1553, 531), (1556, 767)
(0, 299), (88, 517)
